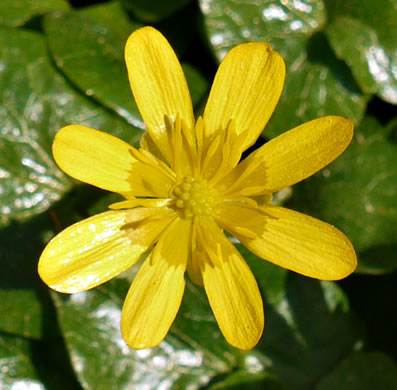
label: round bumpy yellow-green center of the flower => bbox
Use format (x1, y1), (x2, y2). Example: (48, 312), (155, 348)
(172, 176), (215, 218)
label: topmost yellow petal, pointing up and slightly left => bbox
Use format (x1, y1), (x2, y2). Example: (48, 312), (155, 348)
(125, 27), (194, 161)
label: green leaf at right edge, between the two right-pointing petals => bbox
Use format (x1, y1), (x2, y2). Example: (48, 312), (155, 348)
(291, 118), (397, 273)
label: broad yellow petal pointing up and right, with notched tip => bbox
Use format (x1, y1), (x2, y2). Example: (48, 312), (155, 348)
(204, 43), (285, 150)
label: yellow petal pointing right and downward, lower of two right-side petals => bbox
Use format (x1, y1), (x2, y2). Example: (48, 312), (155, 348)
(218, 204), (357, 280)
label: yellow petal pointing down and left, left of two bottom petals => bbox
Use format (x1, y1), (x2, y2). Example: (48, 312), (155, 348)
(121, 219), (191, 349)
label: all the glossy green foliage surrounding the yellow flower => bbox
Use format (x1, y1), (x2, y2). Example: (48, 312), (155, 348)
(0, 0), (397, 390)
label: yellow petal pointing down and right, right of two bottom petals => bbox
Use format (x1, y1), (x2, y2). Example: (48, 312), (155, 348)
(196, 219), (264, 350)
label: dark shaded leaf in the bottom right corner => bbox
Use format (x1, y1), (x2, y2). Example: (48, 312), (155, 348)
(315, 352), (397, 390)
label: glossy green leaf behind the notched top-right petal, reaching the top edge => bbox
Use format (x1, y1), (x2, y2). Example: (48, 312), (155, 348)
(200, 0), (367, 136)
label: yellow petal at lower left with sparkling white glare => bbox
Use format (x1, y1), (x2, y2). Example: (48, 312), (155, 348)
(38, 210), (175, 293)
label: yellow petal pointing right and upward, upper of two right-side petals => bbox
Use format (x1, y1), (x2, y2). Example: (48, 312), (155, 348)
(219, 116), (353, 195)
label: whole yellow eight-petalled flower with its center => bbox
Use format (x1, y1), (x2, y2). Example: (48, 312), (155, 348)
(39, 27), (356, 349)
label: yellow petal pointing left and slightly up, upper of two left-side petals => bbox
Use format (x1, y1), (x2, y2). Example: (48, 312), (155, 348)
(53, 125), (174, 197)
